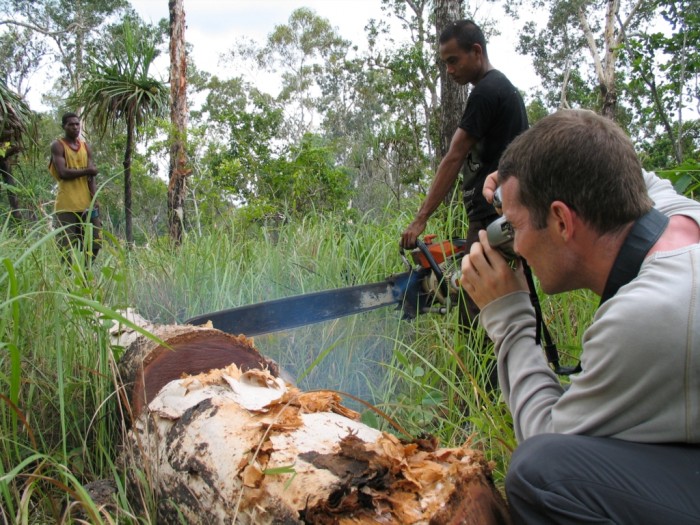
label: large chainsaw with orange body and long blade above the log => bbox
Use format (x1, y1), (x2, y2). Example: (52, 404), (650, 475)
(185, 235), (467, 337)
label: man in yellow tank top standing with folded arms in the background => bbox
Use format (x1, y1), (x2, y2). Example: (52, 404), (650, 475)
(49, 113), (101, 258)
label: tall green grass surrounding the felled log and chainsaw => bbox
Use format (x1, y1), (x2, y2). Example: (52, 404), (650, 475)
(0, 204), (590, 523)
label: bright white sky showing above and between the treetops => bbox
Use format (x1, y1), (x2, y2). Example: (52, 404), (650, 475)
(131, 0), (539, 91)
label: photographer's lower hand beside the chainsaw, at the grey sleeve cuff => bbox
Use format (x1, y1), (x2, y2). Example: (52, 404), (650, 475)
(459, 230), (528, 309)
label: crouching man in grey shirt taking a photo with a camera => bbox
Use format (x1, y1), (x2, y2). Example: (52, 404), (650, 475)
(461, 110), (700, 525)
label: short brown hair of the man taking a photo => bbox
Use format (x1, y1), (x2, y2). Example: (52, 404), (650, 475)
(498, 110), (653, 234)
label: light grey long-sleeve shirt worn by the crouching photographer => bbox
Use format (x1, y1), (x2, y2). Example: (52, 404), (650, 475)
(480, 172), (700, 443)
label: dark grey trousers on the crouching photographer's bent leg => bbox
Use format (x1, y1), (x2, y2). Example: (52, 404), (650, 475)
(506, 434), (700, 525)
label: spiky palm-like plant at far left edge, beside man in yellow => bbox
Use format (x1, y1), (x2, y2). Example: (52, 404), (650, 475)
(0, 79), (34, 219)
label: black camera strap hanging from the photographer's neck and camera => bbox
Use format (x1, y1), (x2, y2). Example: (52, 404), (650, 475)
(521, 208), (669, 376)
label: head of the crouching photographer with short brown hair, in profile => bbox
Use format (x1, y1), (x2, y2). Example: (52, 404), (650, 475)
(498, 110), (652, 294)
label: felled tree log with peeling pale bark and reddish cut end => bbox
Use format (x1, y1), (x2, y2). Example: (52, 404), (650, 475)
(113, 318), (509, 525)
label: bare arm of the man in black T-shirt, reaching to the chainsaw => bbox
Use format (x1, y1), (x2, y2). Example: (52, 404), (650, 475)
(401, 128), (476, 248)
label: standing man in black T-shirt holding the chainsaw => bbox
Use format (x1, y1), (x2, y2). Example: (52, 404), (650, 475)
(401, 20), (528, 332)
